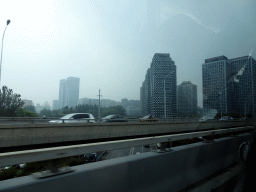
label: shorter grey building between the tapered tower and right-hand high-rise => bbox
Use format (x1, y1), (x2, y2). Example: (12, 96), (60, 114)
(177, 81), (197, 116)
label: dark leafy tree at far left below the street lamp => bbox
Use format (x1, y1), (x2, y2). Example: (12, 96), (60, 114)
(0, 86), (24, 117)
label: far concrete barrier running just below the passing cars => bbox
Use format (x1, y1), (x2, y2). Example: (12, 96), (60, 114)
(0, 121), (254, 147)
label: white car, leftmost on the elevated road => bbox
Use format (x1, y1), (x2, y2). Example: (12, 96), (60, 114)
(49, 113), (95, 123)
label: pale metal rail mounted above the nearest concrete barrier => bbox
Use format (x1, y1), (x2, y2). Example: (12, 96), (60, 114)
(0, 126), (253, 166)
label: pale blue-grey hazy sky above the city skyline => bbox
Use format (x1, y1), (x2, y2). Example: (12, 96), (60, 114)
(0, 0), (256, 106)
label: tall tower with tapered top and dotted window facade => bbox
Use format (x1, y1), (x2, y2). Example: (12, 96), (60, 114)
(141, 53), (177, 117)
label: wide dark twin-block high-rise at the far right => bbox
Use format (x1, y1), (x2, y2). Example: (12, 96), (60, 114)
(203, 56), (256, 115)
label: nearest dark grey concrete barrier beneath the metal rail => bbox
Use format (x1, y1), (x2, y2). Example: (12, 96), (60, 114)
(0, 134), (255, 192)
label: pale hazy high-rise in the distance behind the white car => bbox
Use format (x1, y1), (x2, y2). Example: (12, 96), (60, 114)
(59, 77), (80, 108)
